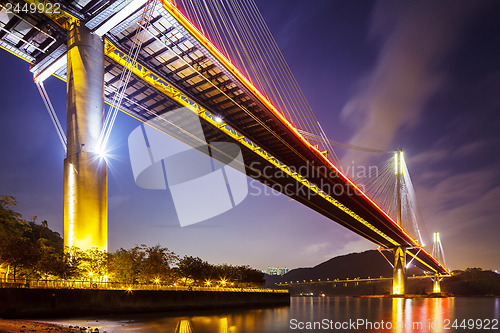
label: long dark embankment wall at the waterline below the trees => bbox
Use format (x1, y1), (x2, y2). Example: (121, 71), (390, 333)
(0, 288), (290, 318)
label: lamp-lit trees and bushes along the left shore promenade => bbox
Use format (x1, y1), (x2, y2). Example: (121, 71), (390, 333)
(0, 195), (265, 287)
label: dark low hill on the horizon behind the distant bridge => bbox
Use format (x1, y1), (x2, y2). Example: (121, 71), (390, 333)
(265, 250), (423, 287)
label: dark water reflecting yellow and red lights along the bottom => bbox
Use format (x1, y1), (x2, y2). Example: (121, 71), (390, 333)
(47, 297), (500, 333)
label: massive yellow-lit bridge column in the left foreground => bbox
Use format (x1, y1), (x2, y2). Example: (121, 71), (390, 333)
(64, 22), (108, 250)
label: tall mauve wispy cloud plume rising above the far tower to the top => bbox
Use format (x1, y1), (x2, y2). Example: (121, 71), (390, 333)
(342, 1), (480, 165)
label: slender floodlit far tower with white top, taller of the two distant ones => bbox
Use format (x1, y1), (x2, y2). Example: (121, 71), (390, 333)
(392, 150), (406, 295)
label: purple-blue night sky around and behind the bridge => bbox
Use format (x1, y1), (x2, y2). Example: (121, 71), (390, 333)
(0, 0), (500, 269)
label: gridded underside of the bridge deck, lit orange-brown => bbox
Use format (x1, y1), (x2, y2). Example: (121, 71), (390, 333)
(0, 1), (446, 272)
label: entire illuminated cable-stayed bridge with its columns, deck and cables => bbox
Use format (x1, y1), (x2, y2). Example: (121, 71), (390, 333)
(0, 0), (448, 294)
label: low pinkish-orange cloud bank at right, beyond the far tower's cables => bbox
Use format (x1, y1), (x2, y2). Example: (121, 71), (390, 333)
(416, 166), (500, 269)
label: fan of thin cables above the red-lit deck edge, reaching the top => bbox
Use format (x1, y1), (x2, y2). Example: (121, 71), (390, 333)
(170, 0), (340, 165)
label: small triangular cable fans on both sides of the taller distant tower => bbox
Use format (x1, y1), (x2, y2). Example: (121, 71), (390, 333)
(353, 152), (429, 246)
